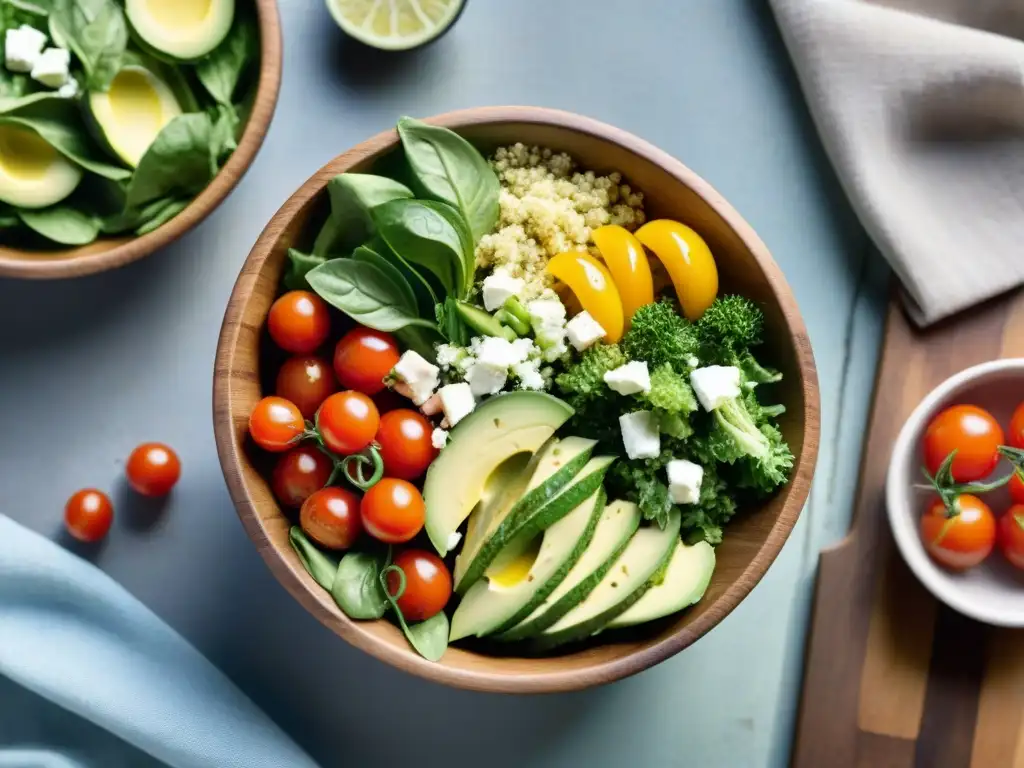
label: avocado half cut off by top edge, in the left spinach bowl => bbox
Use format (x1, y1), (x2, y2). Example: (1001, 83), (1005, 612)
(125, 0), (234, 61)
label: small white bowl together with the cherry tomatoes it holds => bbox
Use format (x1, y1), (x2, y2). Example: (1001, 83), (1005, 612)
(886, 358), (1024, 627)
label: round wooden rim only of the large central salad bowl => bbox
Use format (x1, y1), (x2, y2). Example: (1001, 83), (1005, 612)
(213, 106), (820, 693)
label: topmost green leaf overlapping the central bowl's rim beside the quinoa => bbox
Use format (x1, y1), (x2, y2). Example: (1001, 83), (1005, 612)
(398, 118), (500, 244)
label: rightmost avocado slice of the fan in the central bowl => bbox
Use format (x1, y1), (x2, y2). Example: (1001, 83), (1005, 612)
(605, 541), (715, 630)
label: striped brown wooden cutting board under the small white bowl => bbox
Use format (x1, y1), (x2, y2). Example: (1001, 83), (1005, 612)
(793, 292), (1024, 768)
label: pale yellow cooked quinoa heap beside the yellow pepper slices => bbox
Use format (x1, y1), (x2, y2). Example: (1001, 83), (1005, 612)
(476, 143), (644, 299)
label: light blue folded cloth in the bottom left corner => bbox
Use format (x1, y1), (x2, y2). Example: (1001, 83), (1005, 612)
(0, 515), (316, 768)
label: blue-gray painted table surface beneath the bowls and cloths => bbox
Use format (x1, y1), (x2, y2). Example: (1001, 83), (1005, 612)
(0, 0), (888, 768)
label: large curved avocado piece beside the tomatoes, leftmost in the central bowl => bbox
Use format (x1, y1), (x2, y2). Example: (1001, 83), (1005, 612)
(423, 391), (572, 557)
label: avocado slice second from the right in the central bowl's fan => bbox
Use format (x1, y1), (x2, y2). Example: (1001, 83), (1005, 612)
(532, 511), (680, 650)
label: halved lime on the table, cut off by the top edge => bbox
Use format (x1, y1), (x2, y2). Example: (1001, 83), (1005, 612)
(327, 0), (466, 50)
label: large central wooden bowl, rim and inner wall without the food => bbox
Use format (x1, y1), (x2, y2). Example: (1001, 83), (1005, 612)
(213, 106), (819, 693)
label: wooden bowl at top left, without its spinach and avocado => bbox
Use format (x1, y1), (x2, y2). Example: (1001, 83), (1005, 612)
(0, 0), (282, 280)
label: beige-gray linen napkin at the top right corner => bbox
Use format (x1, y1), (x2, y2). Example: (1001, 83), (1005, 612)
(770, 0), (1024, 325)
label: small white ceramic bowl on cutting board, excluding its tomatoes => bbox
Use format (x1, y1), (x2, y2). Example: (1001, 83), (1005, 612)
(886, 358), (1024, 627)
